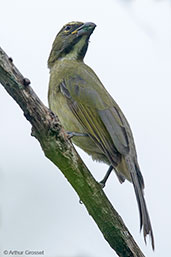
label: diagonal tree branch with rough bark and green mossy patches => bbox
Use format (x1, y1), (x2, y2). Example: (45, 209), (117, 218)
(0, 48), (144, 257)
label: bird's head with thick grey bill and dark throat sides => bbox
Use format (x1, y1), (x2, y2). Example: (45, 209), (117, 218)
(48, 22), (96, 68)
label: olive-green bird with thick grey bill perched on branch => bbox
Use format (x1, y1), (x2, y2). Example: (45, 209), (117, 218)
(48, 22), (154, 249)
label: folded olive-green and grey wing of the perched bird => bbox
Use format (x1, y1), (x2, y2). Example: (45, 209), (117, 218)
(60, 72), (129, 164)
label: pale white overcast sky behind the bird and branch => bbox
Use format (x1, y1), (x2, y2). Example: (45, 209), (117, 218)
(0, 0), (171, 257)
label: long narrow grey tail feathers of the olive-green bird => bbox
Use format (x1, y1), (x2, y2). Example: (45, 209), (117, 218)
(130, 164), (154, 250)
